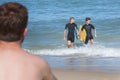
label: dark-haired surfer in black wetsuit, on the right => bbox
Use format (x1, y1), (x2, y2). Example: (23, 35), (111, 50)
(80, 17), (96, 44)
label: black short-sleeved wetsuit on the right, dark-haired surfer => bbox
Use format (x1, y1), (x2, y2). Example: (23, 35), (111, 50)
(82, 24), (95, 44)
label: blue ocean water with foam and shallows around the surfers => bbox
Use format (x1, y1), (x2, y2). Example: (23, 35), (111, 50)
(0, 0), (120, 72)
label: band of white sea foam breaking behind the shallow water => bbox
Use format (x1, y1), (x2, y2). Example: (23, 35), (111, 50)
(25, 45), (120, 57)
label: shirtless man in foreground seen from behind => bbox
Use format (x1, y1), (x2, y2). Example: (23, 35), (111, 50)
(0, 2), (56, 80)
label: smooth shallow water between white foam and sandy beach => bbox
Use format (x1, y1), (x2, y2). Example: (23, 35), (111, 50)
(42, 55), (120, 73)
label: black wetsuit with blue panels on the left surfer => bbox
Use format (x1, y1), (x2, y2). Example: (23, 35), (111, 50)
(65, 23), (78, 42)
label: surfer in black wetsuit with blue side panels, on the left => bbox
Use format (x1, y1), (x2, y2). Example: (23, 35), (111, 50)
(64, 17), (78, 47)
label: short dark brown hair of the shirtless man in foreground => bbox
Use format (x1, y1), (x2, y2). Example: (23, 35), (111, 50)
(0, 2), (28, 42)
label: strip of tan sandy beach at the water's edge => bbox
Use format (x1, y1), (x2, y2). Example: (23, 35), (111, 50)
(52, 69), (120, 80)
